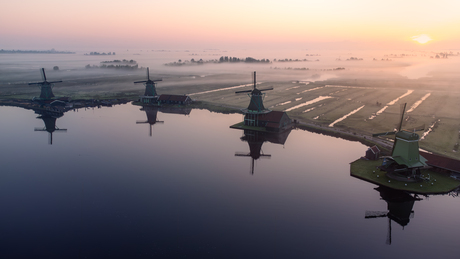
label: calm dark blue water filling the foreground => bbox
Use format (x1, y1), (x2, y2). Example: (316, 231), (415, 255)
(0, 104), (460, 258)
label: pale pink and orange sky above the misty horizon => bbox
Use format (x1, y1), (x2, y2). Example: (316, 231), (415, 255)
(0, 0), (460, 49)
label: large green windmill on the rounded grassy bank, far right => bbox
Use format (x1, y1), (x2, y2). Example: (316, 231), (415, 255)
(372, 104), (426, 181)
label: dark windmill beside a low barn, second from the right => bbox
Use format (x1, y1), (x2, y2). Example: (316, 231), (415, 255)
(235, 71), (273, 127)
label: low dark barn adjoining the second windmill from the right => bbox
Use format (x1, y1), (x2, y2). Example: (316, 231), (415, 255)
(244, 111), (292, 132)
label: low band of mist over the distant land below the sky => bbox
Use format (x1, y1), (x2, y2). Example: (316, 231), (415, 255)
(0, 48), (460, 99)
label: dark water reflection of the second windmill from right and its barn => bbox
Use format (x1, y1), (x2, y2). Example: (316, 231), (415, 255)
(235, 130), (291, 175)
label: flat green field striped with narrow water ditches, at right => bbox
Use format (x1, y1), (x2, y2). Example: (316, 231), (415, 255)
(182, 76), (460, 159)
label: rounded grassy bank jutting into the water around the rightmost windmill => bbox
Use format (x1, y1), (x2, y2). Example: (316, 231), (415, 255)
(350, 159), (460, 194)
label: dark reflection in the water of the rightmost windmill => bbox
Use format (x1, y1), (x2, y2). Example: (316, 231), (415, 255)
(364, 186), (421, 245)
